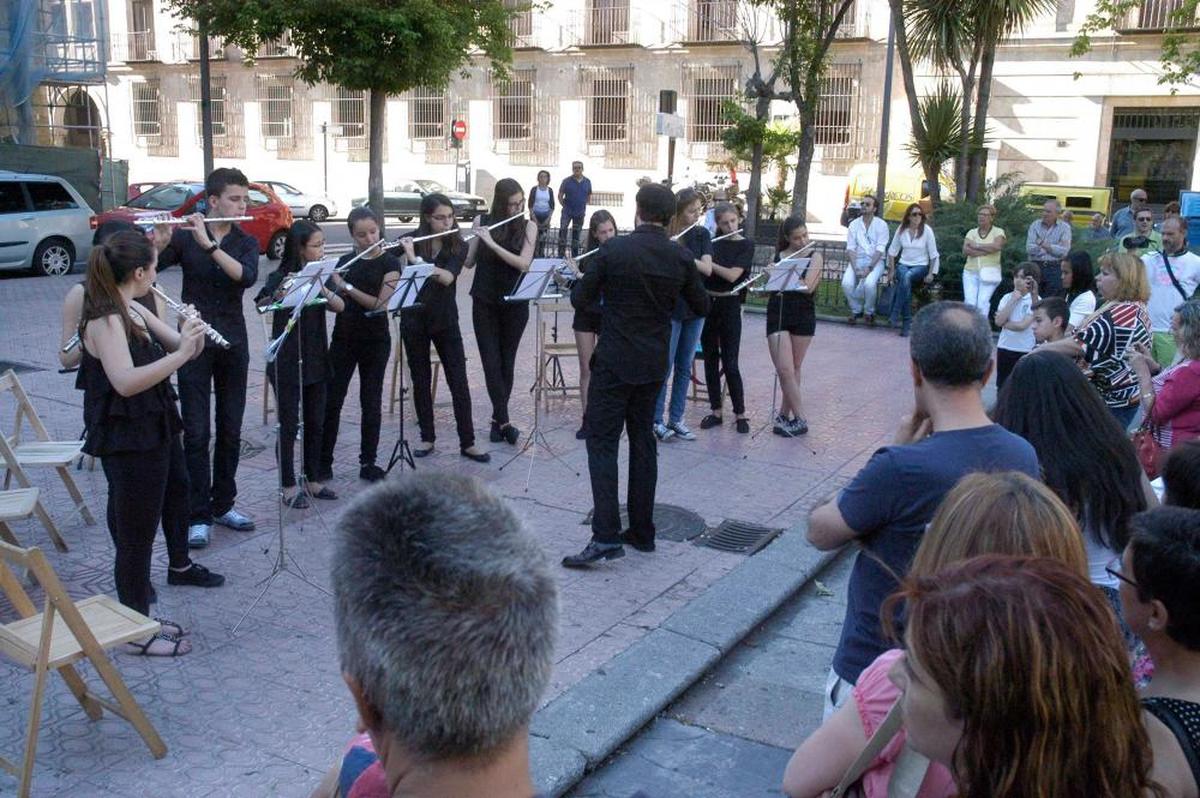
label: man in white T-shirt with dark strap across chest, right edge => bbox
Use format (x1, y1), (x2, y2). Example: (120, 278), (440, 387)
(1141, 216), (1200, 367)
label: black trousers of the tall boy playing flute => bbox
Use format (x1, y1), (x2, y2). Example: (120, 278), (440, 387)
(179, 343), (250, 523)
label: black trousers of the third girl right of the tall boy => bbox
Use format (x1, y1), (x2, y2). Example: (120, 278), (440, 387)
(401, 323), (475, 449)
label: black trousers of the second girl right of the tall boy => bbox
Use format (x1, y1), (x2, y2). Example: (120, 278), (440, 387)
(319, 336), (391, 480)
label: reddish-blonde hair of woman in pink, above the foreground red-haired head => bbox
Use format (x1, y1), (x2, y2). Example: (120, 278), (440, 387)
(908, 472), (1087, 578)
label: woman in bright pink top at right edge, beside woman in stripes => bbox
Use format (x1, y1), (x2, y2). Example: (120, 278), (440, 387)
(1129, 299), (1200, 451)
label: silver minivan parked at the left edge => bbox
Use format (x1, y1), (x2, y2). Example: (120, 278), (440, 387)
(0, 172), (95, 275)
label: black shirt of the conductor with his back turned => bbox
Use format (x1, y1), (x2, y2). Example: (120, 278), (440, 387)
(571, 224), (708, 385)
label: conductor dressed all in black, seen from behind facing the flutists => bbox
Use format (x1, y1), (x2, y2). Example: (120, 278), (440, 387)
(563, 184), (708, 568)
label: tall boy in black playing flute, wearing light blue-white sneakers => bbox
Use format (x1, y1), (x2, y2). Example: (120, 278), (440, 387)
(154, 167), (258, 548)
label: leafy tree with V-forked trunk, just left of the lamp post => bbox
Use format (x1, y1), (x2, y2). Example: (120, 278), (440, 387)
(763, 0), (854, 218)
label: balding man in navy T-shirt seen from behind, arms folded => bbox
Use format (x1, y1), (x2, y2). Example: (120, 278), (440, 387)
(808, 302), (1039, 716)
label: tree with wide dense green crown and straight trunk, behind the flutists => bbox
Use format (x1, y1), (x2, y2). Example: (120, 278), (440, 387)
(167, 0), (514, 219)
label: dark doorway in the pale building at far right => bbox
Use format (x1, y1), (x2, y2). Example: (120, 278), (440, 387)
(1109, 106), (1200, 205)
